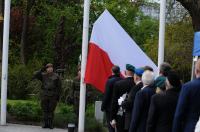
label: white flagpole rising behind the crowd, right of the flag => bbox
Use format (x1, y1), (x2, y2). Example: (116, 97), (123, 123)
(158, 0), (166, 72)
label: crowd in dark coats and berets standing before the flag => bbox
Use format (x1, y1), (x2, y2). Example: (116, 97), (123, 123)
(101, 60), (200, 132)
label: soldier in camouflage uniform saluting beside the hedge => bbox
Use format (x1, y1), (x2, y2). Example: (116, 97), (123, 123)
(34, 63), (61, 129)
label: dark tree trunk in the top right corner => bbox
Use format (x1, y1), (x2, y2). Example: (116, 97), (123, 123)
(177, 0), (200, 32)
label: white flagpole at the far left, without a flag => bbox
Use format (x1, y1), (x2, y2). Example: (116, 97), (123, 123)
(1, 0), (11, 125)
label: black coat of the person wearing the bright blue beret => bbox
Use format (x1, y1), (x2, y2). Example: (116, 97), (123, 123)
(122, 82), (143, 130)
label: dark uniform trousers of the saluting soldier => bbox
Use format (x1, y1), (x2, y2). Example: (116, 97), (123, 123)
(41, 96), (58, 121)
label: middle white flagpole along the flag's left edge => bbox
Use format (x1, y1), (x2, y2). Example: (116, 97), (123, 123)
(78, 0), (90, 132)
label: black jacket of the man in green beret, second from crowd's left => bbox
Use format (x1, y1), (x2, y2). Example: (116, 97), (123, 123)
(111, 77), (135, 119)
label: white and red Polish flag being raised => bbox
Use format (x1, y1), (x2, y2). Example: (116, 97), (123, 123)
(85, 10), (158, 92)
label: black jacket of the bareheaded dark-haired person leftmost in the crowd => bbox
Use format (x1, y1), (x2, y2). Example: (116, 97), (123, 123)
(101, 75), (122, 112)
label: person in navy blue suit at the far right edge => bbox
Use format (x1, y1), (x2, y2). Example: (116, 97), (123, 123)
(173, 60), (200, 132)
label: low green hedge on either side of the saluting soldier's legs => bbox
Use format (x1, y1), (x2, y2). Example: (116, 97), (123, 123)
(7, 100), (76, 128)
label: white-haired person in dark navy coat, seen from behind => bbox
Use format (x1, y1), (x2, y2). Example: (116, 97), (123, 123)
(129, 71), (155, 132)
